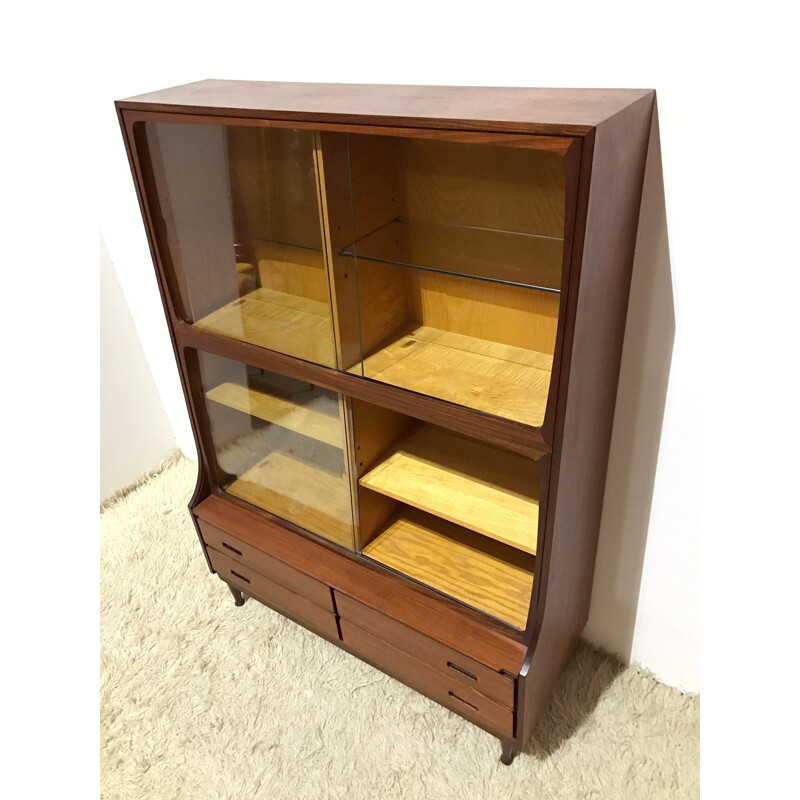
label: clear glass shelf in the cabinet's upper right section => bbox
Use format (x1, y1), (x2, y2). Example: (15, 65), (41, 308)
(340, 218), (564, 292)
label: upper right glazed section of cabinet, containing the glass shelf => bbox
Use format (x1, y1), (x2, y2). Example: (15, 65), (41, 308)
(337, 135), (565, 426)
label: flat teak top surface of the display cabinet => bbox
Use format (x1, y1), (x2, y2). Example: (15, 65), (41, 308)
(117, 80), (652, 136)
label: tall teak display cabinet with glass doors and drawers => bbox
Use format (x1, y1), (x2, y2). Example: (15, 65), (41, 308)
(117, 81), (655, 763)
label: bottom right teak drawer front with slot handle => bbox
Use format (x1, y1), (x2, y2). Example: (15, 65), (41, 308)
(339, 619), (514, 739)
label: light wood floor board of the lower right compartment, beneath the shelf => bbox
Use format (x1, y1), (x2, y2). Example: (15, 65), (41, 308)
(363, 509), (534, 628)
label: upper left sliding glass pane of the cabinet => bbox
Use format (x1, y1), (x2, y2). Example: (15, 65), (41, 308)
(137, 122), (336, 366)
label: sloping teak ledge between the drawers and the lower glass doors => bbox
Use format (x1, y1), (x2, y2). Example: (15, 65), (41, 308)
(194, 495), (526, 675)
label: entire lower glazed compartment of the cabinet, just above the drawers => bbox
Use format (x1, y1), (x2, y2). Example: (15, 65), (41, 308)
(193, 351), (539, 628)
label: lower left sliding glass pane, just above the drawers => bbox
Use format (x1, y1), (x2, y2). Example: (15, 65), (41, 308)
(198, 352), (353, 549)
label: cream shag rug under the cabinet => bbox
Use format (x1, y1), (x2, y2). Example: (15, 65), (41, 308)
(100, 458), (699, 800)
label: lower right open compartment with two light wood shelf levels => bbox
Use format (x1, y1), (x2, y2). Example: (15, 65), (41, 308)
(352, 399), (539, 628)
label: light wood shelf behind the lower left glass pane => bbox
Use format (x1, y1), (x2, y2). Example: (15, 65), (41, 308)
(206, 383), (342, 449)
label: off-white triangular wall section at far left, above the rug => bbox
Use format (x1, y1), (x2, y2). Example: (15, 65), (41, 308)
(100, 239), (177, 500)
